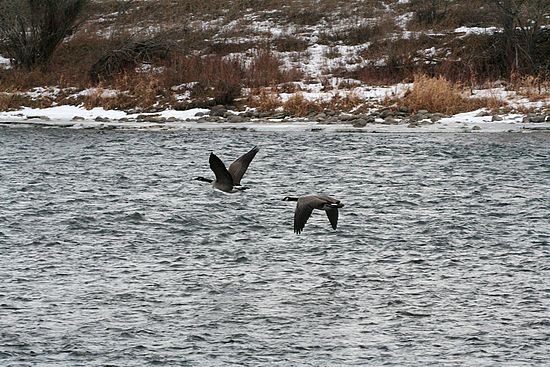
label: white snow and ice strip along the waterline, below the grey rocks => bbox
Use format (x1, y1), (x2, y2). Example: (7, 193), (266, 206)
(0, 106), (550, 133)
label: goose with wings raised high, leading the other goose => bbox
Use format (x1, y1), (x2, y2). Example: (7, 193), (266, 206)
(195, 147), (260, 193)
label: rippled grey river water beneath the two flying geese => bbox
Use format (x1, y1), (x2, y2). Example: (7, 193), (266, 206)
(0, 128), (550, 366)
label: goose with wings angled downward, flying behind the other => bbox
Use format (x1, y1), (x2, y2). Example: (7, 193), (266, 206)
(283, 195), (344, 234)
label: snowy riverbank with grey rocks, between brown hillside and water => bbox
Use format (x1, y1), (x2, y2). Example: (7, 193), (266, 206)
(0, 106), (550, 133)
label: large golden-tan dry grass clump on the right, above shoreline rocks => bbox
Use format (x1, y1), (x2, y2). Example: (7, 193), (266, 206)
(399, 74), (502, 115)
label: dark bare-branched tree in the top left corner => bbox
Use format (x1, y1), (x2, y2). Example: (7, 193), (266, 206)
(0, 0), (88, 69)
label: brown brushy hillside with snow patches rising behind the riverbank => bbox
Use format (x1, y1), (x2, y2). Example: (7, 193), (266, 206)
(0, 0), (550, 125)
